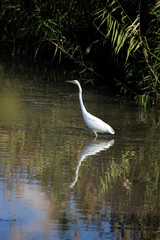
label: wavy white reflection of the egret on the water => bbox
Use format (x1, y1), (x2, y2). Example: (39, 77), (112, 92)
(70, 139), (114, 188)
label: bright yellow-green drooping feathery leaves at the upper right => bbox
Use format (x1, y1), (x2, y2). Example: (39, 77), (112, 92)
(94, 0), (137, 57)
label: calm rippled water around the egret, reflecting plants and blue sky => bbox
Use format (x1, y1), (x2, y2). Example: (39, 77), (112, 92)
(0, 61), (160, 240)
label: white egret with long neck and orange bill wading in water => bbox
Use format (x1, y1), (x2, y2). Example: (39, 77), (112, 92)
(66, 80), (115, 137)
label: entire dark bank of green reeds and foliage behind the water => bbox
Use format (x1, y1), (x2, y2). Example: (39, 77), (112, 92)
(0, 0), (160, 106)
